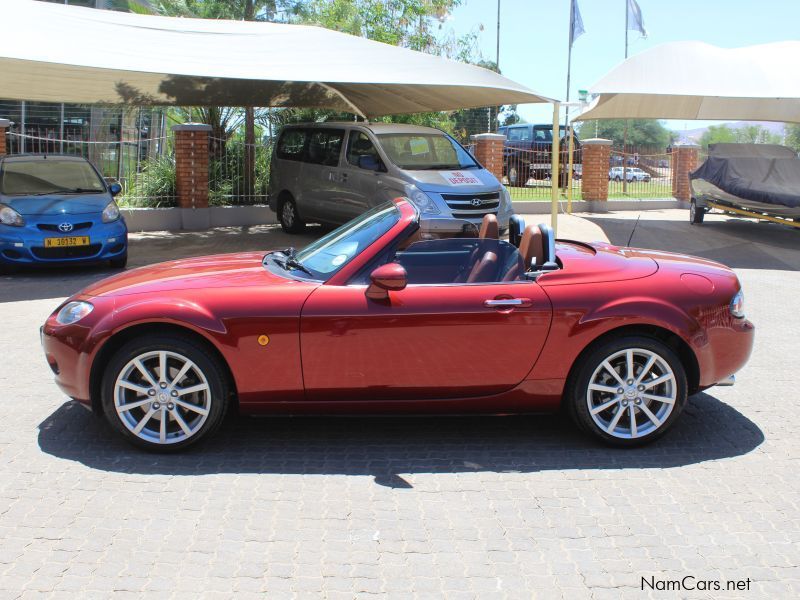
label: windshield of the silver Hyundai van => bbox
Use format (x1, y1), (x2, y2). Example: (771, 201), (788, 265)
(378, 133), (480, 170)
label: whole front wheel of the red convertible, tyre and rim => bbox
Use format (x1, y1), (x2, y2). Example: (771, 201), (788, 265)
(102, 336), (229, 452)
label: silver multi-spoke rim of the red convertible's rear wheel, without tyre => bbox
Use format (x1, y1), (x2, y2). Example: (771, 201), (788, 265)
(586, 348), (678, 439)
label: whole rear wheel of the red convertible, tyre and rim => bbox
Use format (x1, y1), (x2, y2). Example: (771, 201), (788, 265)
(565, 336), (688, 446)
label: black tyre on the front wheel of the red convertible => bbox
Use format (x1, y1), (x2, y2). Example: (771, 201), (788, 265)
(101, 335), (230, 453)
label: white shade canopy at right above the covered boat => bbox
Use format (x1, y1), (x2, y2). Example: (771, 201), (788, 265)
(577, 41), (800, 122)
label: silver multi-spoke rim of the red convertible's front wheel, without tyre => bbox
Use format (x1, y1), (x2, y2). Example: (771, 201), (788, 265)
(114, 350), (212, 444)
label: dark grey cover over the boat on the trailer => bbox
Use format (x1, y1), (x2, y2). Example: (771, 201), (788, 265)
(689, 144), (800, 208)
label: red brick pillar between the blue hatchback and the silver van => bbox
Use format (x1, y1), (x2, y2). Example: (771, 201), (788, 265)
(172, 123), (211, 208)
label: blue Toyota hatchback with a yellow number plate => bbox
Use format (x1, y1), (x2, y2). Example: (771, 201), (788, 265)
(0, 154), (128, 270)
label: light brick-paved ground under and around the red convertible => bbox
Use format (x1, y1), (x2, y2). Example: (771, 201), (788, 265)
(0, 211), (800, 599)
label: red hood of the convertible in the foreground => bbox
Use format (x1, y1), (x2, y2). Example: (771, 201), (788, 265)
(81, 252), (310, 296)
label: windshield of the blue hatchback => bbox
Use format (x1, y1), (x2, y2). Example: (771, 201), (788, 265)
(0, 158), (105, 196)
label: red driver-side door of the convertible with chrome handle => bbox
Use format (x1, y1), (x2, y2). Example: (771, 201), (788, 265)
(300, 238), (551, 401)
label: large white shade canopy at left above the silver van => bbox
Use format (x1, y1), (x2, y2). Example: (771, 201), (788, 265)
(0, 0), (551, 117)
